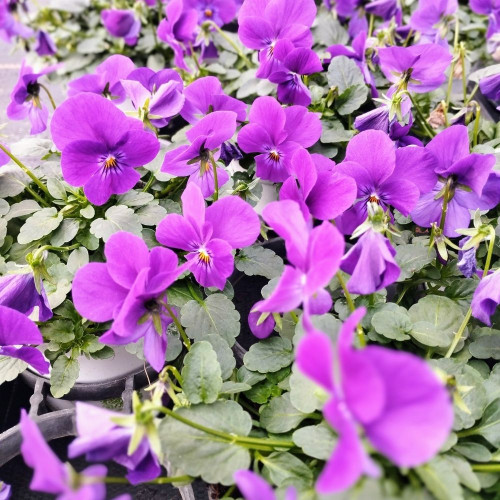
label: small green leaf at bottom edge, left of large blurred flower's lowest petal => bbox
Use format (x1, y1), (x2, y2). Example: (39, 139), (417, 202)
(260, 451), (313, 488)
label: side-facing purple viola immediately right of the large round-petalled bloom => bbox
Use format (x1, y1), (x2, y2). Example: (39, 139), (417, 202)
(161, 111), (236, 198)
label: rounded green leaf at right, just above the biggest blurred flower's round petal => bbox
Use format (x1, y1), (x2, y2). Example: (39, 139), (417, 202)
(408, 295), (464, 348)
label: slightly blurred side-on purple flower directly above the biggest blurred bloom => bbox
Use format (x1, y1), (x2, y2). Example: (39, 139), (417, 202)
(253, 200), (344, 315)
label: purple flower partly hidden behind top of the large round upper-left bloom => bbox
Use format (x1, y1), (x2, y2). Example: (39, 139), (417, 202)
(68, 54), (135, 104)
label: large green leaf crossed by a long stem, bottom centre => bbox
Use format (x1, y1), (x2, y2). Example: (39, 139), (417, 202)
(159, 401), (252, 485)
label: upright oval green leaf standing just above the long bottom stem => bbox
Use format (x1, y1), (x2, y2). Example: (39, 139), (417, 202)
(182, 341), (222, 404)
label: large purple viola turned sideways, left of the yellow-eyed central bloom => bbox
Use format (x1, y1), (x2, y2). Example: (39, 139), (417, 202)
(73, 231), (186, 372)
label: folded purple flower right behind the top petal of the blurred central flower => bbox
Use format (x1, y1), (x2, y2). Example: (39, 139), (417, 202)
(280, 148), (357, 220)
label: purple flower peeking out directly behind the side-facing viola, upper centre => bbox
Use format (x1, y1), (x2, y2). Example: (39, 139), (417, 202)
(181, 76), (247, 124)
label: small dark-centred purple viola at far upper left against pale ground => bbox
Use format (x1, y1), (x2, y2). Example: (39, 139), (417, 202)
(7, 61), (55, 135)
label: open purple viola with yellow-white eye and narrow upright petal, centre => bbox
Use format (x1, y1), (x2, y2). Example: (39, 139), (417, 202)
(156, 183), (260, 290)
